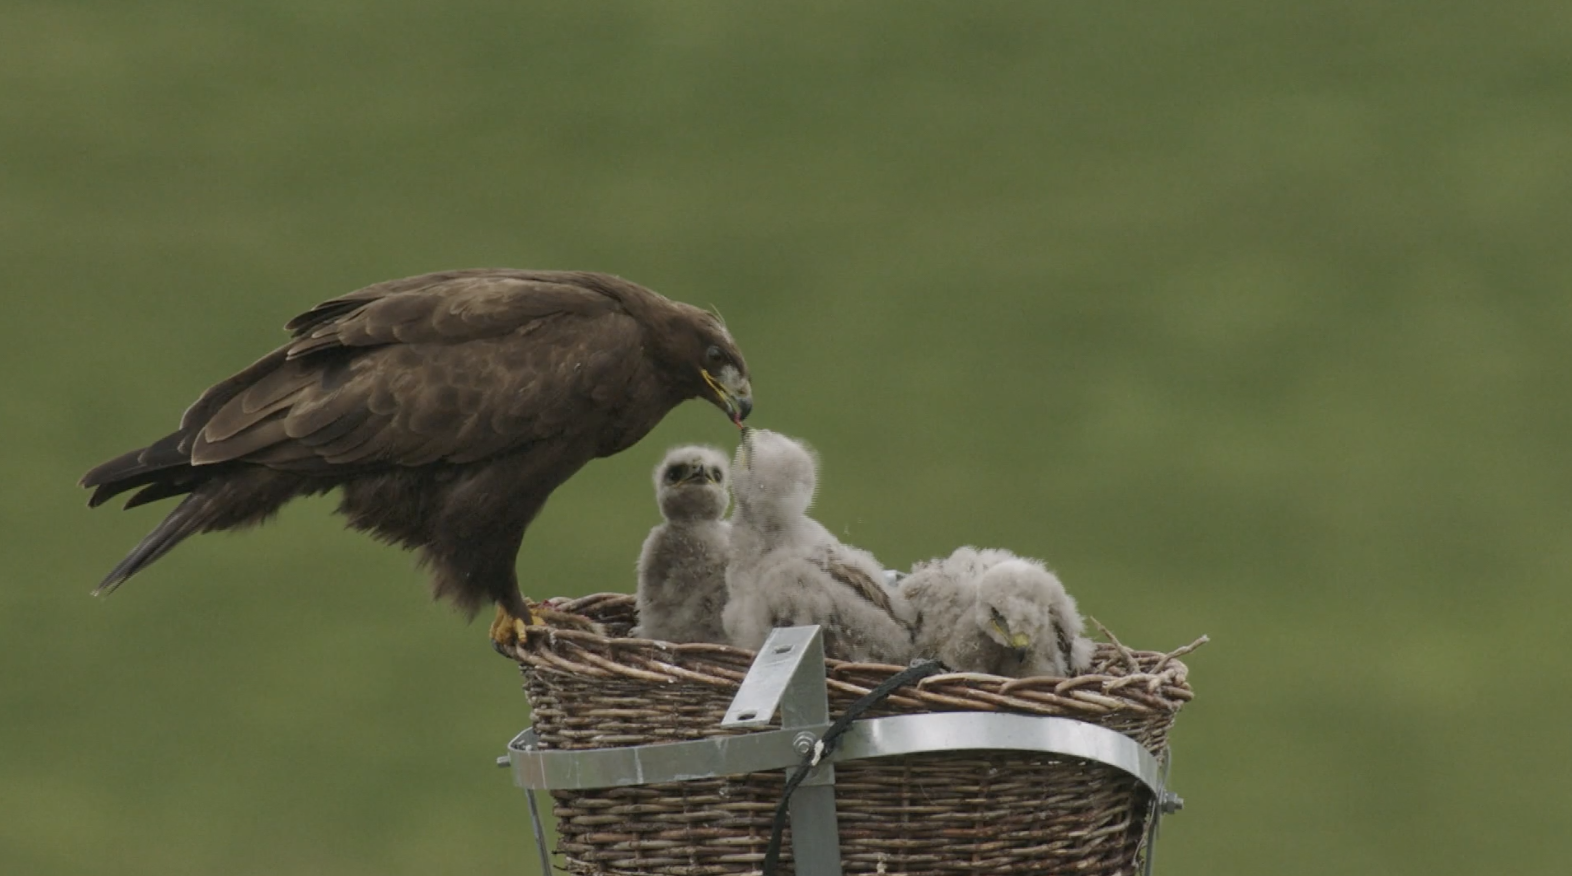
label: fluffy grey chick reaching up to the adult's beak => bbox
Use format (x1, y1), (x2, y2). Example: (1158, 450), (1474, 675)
(723, 429), (916, 664)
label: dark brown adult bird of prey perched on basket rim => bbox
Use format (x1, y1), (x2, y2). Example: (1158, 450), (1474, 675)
(82, 269), (753, 643)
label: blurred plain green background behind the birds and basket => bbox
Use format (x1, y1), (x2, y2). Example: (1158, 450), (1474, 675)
(0, 0), (1572, 876)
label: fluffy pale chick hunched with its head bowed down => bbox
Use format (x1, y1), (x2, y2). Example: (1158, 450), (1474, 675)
(901, 547), (1093, 678)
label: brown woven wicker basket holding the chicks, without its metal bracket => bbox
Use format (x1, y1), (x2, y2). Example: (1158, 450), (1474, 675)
(512, 593), (1204, 876)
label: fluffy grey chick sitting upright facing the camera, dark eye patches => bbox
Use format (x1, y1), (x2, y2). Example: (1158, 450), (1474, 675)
(634, 445), (731, 643)
